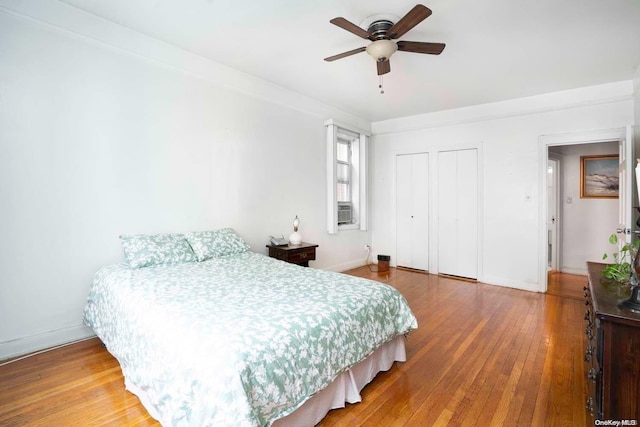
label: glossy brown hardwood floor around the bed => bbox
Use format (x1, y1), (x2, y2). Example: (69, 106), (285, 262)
(0, 267), (586, 426)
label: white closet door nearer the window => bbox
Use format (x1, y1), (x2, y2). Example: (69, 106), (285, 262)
(396, 153), (429, 270)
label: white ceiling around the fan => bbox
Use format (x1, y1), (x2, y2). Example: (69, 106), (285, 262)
(58, 0), (640, 121)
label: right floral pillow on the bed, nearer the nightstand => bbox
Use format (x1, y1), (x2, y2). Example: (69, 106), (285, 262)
(185, 228), (250, 261)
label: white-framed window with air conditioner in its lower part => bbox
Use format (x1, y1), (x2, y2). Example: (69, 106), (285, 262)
(325, 120), (369, 234)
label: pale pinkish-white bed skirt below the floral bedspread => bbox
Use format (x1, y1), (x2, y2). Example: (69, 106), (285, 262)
(125, 335), (407, 427)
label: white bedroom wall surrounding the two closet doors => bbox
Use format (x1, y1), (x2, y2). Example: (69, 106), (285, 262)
(371, 82), (633, 290)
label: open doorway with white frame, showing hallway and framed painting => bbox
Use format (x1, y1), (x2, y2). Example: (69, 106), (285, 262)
(539, 128), (632, 292)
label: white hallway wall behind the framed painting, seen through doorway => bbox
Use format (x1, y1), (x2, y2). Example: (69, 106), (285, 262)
(559, 142), (618, 275)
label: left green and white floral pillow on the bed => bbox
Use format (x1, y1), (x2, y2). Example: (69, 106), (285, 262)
(120, 234), (197, 268)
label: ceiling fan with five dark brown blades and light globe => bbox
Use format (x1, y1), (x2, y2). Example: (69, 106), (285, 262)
(324, 4), (445, 83)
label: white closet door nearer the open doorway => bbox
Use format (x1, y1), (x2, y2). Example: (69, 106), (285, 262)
(438, 149), (478, 279)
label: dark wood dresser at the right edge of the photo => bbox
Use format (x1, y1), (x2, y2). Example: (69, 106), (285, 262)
(584, 262), (640, 425)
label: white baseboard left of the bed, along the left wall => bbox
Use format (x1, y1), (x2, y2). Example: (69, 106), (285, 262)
(0, 325), (95, 363)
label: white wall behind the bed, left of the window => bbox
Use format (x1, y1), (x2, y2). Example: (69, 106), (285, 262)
(0, 8), (369, 359)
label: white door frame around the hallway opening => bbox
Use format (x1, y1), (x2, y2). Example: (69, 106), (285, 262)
(538, 128), (627, 292)
